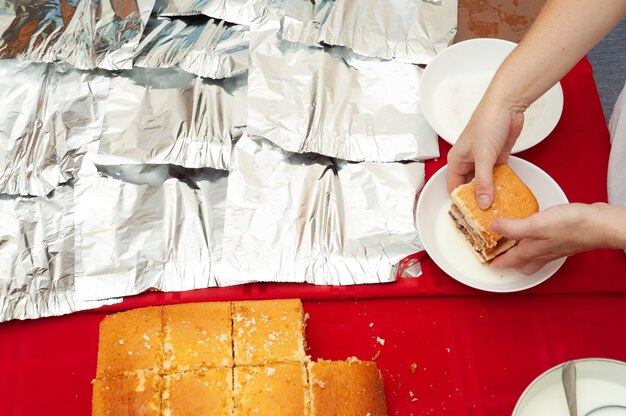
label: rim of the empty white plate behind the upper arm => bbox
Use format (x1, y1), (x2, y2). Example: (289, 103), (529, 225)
(419, 38), (565, 154)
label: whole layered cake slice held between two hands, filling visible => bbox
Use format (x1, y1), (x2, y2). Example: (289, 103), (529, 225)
(449, 164), (539, 263)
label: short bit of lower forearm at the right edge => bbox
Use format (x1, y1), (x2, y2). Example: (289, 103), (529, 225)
(589, 203), (626, 249)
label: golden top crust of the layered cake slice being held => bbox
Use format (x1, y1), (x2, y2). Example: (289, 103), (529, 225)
(450, 164), (539, 247)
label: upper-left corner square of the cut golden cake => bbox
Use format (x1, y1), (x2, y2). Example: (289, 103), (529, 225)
(96, 307), (163, 377)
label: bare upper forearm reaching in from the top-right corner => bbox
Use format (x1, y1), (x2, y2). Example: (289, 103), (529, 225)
(486, 0), (626, 111)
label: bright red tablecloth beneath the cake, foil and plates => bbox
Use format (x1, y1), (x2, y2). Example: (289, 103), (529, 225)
(0, 59), (626, 416)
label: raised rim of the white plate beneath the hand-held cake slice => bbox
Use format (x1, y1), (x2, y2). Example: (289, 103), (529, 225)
(416, 156), (569, 293)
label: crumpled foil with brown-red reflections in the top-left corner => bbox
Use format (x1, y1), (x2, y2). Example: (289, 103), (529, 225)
(0, 0), (155, 70)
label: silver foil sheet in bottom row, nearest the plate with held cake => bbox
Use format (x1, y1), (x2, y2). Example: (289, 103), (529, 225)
(220, 136), (424, 285)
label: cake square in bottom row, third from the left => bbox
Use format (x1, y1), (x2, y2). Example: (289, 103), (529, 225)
(233, 362), (309, 416)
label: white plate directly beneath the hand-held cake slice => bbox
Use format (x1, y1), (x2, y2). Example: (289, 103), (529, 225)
(417, 156), (568, 292)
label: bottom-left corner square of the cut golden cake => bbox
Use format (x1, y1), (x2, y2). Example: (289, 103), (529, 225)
(91, 371), (162, 416)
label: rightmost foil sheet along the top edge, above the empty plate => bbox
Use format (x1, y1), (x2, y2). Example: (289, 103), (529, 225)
(280, 0), (458, 64)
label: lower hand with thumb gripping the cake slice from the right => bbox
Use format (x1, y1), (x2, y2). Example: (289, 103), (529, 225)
(490, 204), (607, 275)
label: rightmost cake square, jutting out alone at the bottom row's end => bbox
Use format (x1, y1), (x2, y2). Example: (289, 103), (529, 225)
(308, 359), (387, 416)
